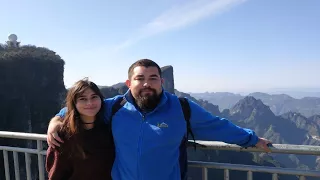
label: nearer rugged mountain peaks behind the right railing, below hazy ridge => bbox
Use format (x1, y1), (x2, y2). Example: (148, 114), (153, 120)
(226, 96), (320, 174)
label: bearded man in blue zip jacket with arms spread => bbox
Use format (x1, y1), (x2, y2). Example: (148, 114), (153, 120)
(48, 59), (270, 180)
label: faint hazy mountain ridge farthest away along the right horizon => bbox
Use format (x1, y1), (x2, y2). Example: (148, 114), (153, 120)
(191, 92), (320, 117)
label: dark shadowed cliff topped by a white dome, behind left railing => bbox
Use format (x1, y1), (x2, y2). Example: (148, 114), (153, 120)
(0, 46), (65, 179)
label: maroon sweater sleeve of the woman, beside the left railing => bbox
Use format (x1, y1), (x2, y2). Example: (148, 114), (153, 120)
(46, 147), (72, 180)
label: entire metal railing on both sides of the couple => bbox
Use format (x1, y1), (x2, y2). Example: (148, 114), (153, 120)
(0, 131), (320, 180)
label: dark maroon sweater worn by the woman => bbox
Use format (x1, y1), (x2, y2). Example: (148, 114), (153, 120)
(46, 125), (115, 180)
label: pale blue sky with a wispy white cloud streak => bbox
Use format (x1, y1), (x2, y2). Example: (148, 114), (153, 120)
(0, 0), (320, 92)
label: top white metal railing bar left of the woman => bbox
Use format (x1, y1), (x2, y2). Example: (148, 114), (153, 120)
(0, 131), (47, 141)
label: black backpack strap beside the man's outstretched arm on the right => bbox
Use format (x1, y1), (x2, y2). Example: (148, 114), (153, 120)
(179, 97), (196, 149)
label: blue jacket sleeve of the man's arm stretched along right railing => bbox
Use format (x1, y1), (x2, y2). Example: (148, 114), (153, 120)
(188, 100), (258, 147)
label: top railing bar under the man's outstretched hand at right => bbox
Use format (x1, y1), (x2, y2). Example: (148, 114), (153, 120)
(189, 141), (320, 156)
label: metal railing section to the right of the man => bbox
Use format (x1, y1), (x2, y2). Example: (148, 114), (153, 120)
(189, 141), (320, 180)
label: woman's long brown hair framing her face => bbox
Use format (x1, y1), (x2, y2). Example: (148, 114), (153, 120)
(61, 78), (104, 158)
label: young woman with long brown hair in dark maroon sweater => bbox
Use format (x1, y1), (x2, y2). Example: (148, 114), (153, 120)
(46, 79), (115, 180)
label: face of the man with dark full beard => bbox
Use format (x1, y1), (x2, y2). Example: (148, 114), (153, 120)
(126, 66), (163, 109)
